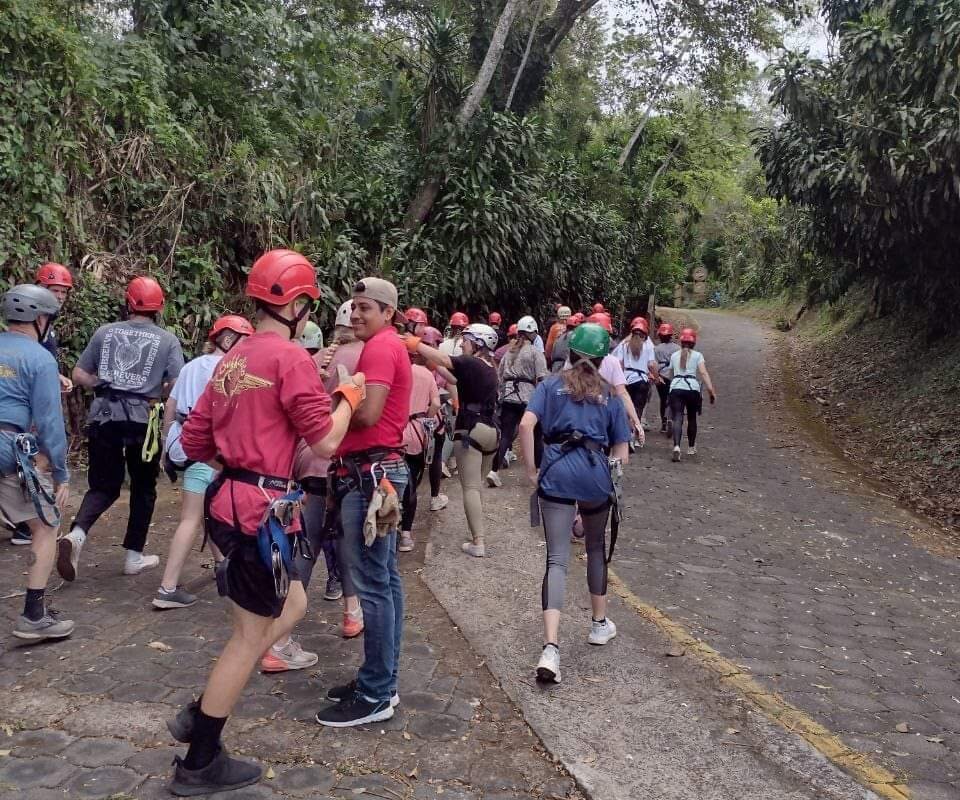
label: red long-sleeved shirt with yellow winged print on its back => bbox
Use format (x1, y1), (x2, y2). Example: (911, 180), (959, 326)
(180, 333), (332, 534)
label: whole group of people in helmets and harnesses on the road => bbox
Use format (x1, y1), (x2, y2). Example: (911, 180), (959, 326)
(0, 260), (716, 796)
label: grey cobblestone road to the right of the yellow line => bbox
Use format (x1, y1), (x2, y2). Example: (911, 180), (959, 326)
(615, 313), (960, 800)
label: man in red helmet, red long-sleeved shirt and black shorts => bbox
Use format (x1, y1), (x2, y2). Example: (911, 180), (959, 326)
(168, 250), (363, 796)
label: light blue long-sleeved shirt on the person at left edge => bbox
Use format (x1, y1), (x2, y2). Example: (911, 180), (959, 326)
(0, 332), (68, 483)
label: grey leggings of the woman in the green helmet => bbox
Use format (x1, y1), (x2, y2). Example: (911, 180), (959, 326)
(540, 497), (610, 611)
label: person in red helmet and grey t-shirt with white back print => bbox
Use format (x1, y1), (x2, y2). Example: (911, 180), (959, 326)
(57, 277), (183, 581)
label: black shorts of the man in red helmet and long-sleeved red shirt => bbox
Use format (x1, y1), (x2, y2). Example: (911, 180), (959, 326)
(209, 517), (300, 617)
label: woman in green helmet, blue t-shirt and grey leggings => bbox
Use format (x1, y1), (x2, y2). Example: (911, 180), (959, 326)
(520, 323), (631, 683)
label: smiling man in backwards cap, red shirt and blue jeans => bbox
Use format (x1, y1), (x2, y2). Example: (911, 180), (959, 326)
(317, 278), (413, 728)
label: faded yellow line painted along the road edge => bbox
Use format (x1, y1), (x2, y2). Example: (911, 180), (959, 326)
(609, 570), (911, 800)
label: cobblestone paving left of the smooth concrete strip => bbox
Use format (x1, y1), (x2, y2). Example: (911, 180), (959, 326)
(0, 489), (580, 800)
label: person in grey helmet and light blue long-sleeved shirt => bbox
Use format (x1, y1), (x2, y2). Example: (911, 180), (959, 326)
(0, 284), (74, 641)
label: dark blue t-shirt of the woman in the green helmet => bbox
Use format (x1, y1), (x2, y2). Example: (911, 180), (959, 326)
(527, 375), (630, 503)
